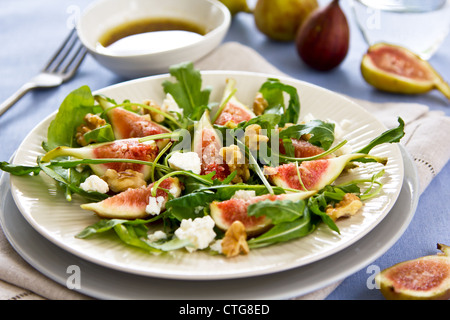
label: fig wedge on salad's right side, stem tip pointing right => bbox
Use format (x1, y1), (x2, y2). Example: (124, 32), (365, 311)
(264, 153), (386, 190)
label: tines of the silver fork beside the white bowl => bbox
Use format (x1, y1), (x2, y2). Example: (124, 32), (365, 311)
(42, 28), (86, 74)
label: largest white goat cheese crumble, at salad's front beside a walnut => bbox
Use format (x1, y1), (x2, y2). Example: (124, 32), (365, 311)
(175, 216), (216, 252)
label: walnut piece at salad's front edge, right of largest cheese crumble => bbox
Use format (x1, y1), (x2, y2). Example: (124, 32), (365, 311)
(222, 221), (250, 258)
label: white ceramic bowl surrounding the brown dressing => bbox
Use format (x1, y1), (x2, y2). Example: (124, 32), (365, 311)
(77, 0), (231, 78)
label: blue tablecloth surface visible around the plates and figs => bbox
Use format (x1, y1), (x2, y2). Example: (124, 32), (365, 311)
(0, 0), (450, 300)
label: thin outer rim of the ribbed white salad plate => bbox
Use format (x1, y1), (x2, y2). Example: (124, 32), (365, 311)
(6, 70), (404, 280)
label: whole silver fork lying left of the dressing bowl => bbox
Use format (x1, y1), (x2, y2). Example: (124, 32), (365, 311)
(0, 28), (87, 116)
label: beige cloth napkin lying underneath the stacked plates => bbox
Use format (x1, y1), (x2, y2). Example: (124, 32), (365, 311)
(0, 42), (450, 300)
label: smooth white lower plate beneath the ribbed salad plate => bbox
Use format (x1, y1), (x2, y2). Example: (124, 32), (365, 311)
(0, 148), (419, 300)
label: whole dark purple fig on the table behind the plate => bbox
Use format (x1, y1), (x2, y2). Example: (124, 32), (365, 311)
(295, 0), (350, 71)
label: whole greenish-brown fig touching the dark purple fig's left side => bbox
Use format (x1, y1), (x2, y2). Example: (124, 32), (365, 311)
(253, 0), (319, 42)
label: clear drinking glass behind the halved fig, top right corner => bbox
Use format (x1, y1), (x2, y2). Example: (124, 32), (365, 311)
(352, 0), (450, 60)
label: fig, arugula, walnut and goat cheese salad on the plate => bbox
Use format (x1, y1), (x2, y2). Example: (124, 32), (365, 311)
(0, 62), (404, 258)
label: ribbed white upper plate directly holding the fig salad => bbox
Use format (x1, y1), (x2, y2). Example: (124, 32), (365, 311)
(7, 71), (404, 280)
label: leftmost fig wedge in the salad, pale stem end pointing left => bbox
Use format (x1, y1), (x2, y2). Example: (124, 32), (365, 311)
(42, 138), (159, 180)
